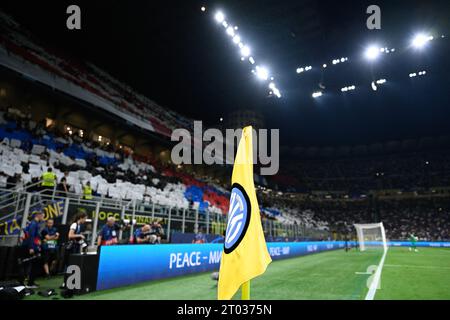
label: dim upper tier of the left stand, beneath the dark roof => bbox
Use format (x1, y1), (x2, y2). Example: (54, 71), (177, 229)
(0, 12), (193, 137)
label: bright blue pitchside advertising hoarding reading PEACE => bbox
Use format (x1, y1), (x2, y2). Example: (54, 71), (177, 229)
(97, 241), (450, 290)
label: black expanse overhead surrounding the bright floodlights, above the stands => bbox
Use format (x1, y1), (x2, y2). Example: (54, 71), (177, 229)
(0, 0), (450, 146)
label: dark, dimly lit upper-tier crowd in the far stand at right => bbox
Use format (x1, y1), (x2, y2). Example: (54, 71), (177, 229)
(275, 148), (450, 194)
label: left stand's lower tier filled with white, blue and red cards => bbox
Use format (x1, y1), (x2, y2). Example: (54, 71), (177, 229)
(0, 108), (228, 213)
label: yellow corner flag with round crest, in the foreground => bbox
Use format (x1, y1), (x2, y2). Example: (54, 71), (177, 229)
(217, 126), (272, 300)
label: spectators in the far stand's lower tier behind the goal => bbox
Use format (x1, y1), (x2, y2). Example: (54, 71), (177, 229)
(263, 196), (450, 241)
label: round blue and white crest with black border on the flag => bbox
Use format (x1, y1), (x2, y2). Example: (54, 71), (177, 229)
(224, 183), (252, 254)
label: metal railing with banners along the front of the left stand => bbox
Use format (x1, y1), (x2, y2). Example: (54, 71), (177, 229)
(0, 189), (329, 246)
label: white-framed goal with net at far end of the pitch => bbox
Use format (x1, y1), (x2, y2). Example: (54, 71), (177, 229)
(354, 222), (387, 251)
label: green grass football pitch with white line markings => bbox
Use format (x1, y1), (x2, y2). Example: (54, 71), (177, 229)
(27, 248), (450, 300)
